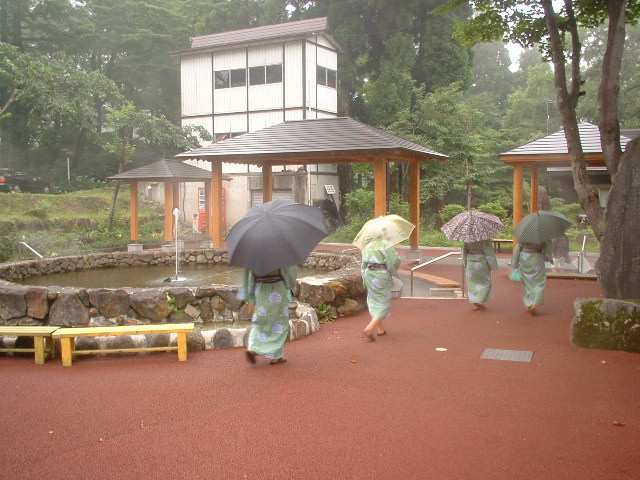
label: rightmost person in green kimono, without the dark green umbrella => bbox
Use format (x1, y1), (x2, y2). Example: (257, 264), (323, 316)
(511, 242), (551, 315)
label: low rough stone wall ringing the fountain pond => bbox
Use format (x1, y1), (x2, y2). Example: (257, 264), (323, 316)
(0, 249), (364, 349)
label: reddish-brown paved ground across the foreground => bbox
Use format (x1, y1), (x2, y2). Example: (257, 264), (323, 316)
(0, 271), (640, 480)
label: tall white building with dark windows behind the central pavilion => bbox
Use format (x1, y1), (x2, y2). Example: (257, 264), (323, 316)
(150, 18), (339, 228)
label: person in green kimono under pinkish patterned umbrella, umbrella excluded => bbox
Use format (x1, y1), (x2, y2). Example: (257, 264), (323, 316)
(462, 240), (498, 310)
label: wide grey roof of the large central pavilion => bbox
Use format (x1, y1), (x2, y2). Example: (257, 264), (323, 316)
(176, 117), (447, 163)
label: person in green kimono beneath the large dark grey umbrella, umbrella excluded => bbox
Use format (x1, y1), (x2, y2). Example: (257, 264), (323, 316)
(238, 266), (297, 365)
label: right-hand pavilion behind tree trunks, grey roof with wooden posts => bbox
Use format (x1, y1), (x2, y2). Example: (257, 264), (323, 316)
(500, 122), (630, 227)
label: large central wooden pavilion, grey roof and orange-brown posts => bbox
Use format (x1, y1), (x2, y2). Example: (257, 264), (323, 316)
(176, 117), (447, 248)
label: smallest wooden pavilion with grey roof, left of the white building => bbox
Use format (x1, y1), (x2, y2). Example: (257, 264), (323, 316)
(109, 160), (224, 242)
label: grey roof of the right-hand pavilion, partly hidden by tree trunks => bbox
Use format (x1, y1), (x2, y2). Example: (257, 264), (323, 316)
(500, 122), (631, 165)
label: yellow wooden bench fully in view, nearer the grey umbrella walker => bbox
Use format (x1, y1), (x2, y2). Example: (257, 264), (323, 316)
(53, 323), (193, 367)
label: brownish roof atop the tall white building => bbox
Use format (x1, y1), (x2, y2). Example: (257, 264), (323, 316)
(191, 17), (327, 49)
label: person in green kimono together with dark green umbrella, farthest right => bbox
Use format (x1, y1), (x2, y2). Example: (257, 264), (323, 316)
(511, 210), (571, 315)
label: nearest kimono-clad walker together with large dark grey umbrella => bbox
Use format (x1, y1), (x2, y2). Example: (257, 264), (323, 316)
(227, 200), (327, 364)
